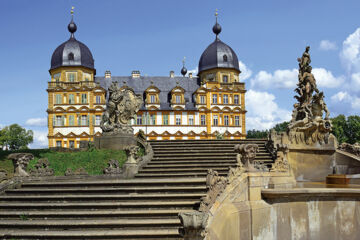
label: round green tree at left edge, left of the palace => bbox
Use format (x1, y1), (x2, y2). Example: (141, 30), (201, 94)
(0, 124), (34, 150)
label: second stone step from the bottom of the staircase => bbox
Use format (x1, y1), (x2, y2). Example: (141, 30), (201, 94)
(0, 218), (181, 230)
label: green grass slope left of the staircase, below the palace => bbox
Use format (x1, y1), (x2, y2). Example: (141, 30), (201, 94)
(0, 149), (126, 177)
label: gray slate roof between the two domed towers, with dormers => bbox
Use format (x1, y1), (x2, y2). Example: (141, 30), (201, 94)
(95, 76), (200, 110)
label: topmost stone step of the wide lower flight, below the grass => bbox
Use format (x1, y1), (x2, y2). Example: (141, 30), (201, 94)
(21, 178), (206, 188)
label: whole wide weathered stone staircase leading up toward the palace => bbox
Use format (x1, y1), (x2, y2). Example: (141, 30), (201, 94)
(0, 140), (272, 239)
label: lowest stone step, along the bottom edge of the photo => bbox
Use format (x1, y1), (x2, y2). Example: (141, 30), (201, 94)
(0, 227), (182, 240)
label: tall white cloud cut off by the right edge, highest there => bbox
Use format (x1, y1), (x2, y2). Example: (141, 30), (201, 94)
(340, 28), (360, 73)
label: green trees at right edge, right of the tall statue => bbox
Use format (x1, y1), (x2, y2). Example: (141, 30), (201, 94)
(331, 114), (360, 144)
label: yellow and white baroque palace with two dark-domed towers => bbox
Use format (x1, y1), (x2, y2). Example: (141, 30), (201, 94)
(47, 14), (246, 148)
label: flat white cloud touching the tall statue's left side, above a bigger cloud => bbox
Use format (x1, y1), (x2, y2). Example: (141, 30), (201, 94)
(250, 69), (298, 89)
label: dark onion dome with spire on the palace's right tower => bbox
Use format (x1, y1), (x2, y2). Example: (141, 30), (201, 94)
(199, 12), (241, 82)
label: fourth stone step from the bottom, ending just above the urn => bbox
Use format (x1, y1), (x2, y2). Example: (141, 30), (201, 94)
(0, 200), (199, 210)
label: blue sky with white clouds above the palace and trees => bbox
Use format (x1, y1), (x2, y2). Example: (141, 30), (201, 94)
(0, 0), (360, 147)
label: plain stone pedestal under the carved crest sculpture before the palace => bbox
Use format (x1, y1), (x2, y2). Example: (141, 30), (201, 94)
(94, 134), (137, 150)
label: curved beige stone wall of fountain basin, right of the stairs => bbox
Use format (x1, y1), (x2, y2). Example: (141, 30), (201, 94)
(205, 173), (360, 240)
